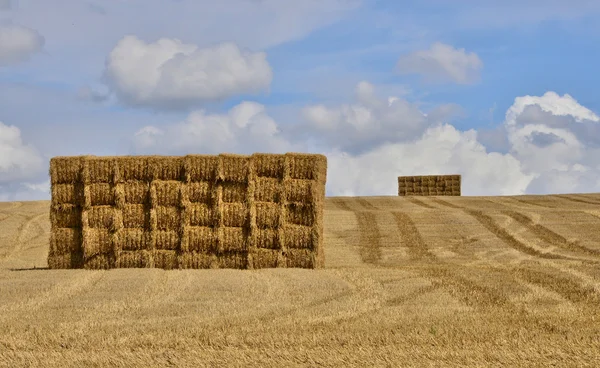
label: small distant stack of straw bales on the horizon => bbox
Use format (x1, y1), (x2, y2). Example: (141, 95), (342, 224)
(398, 175), (460, 196)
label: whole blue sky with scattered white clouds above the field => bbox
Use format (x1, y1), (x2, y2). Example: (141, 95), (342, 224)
(0, 0), (600, 201)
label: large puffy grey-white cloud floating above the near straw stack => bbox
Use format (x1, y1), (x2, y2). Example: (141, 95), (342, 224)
(105, 36), (273, 108)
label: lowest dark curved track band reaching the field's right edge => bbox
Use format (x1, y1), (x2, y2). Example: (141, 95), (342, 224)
(512, 267), (600, 309)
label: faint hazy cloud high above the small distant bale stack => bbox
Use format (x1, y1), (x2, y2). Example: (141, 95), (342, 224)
(396, 42), (483, 84)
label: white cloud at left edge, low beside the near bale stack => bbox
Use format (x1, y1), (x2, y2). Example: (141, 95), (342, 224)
(0, 122), (43, 184)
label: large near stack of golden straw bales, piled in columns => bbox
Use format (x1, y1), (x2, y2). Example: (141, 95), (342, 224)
(48, 153), (327, 269)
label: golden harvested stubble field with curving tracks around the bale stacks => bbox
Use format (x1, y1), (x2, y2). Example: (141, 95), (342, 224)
(0, 194), (600, 367)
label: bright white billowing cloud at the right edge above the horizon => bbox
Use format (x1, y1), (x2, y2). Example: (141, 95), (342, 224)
(504, 91), (600, 193)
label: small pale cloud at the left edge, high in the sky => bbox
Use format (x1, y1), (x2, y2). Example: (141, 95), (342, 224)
(0, 24), (45, 66)
